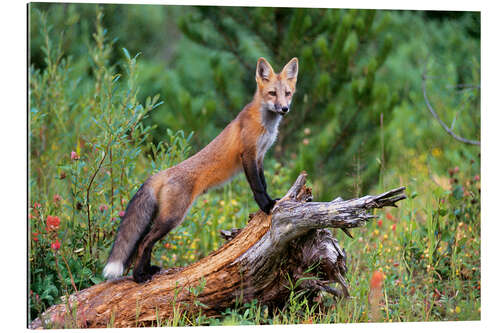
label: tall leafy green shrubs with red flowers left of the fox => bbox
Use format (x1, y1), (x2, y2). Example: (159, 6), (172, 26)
(29, 7), (183, 316)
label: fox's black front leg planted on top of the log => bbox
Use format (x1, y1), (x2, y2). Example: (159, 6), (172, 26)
(241, 152), (276, 214)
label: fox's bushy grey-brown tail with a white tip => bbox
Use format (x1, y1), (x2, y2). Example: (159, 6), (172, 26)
(103, 182), (157, 279)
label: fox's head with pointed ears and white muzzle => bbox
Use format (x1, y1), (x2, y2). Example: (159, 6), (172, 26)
(255, 58), (299, 115)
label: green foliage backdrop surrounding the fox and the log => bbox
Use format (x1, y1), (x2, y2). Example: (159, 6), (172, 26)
(29, 3), (480, 324)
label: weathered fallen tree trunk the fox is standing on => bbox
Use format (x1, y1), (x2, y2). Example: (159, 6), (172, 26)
(30, 173), (405, 328)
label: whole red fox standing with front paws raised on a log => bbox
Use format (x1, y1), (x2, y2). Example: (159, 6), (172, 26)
(103, 58), (299, 283)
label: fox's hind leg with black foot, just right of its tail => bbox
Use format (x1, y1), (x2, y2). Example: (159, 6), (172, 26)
(133, 185), (192, 282)
